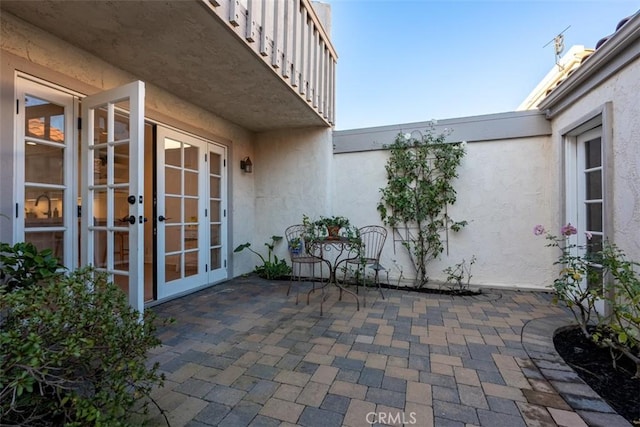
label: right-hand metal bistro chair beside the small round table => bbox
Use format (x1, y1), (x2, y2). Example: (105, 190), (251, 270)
(344, 225), (387, 307)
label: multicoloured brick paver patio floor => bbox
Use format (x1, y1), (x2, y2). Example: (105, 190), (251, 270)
(138, 277), (629, 427)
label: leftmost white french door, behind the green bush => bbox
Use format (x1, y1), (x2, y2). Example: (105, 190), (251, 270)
(14, 77), (78, 267)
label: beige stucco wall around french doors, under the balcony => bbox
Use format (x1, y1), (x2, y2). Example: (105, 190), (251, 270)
(0, 13), (331, 276)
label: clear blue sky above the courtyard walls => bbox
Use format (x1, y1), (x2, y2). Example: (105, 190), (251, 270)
(321, 0), (640, 130)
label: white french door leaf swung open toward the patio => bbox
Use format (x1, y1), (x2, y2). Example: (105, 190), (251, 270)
(81, 81), (146, 312)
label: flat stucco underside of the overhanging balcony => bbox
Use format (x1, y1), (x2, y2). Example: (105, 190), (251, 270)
(0, 0), (328, 131)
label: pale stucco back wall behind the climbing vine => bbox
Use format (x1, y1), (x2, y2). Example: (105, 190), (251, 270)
(334, 135), (559, 289)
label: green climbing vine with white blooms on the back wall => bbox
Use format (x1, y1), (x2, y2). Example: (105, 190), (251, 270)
(378, 125), (467, 287)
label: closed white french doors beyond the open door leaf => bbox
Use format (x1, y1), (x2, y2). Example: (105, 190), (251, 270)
(156, 126), (227, 299)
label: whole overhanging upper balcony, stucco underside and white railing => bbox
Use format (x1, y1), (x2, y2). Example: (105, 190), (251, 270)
(0, 0), (336, 132)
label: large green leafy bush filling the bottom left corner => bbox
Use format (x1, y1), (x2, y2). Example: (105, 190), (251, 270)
(0, 249), (164, 426)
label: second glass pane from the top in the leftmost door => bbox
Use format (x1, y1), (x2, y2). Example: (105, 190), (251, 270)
(24, 142), (64, 184)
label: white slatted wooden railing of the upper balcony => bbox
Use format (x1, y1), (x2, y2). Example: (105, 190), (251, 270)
(202, 0), (337, 124)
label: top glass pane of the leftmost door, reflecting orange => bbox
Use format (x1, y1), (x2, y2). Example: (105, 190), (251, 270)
(25, 96), (65, 144)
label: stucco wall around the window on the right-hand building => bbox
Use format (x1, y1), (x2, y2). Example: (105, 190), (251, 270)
(552, 59), (640, 261)
